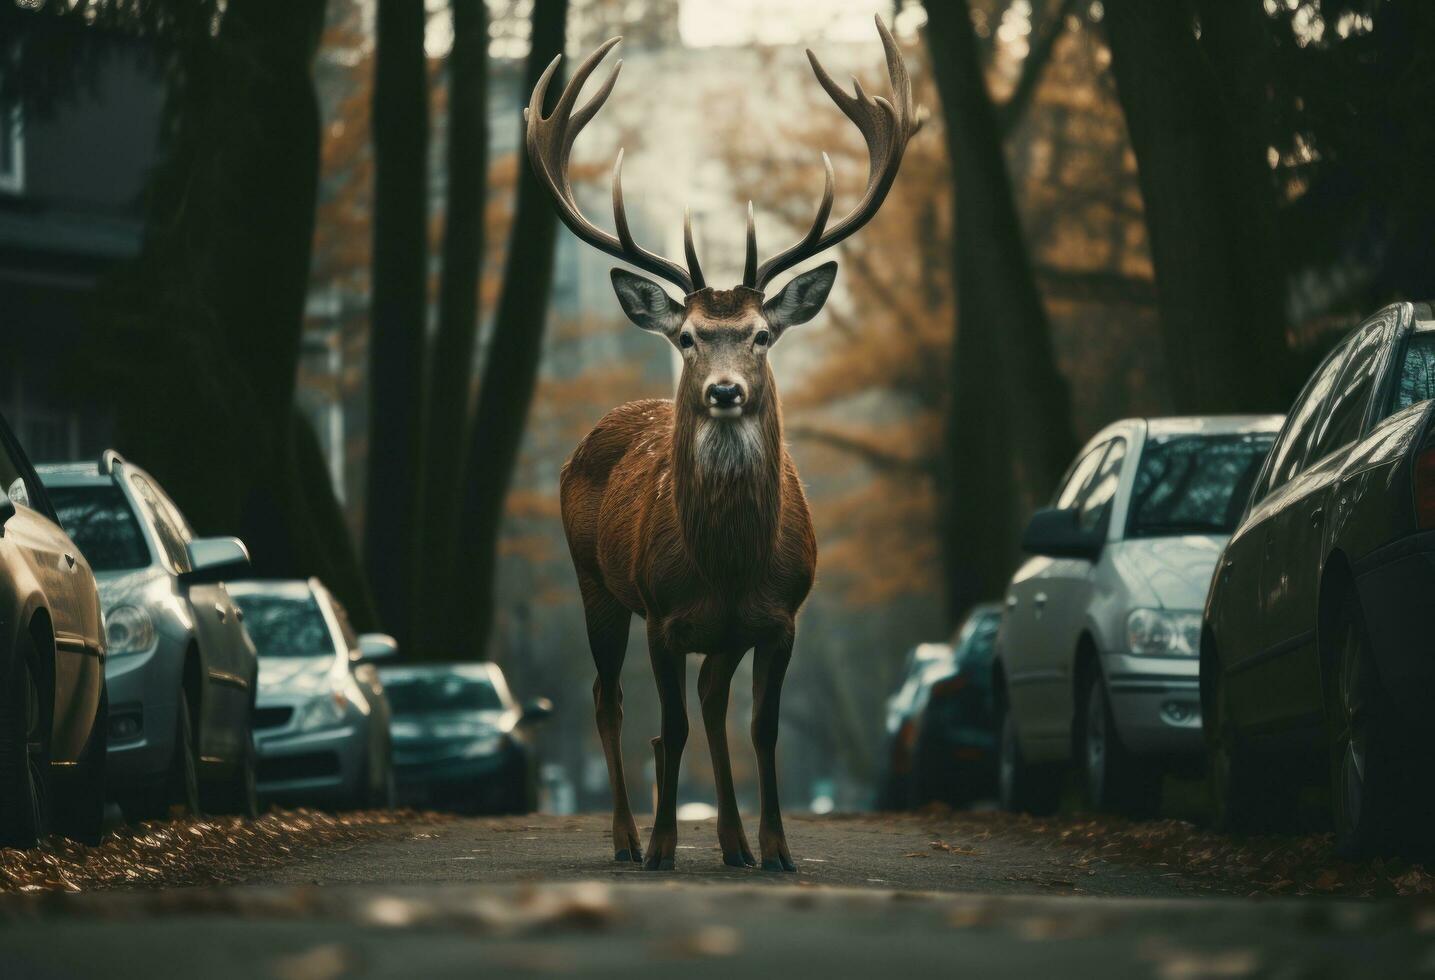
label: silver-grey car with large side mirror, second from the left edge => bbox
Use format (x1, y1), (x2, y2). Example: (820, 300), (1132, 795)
(37, 451), (258, 821)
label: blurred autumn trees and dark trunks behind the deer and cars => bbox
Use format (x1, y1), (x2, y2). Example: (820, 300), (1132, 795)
(0, 0), (1435, 804)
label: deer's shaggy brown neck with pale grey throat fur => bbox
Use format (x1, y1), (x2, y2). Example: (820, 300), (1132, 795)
(673, 393), (782, 587)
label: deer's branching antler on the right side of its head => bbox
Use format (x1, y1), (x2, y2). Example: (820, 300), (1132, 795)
(742, 16), (924, 290)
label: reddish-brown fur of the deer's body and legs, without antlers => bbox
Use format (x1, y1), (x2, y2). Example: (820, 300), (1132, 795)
(560, 288), (817, 871)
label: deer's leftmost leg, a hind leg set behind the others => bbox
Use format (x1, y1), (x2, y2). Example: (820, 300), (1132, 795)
(583, 583), (643, 862)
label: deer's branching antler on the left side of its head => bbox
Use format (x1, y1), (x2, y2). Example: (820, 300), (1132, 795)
(524, 37), (705, 294)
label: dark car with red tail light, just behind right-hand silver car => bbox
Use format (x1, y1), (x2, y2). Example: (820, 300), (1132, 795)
(913, 603), (1002, 806)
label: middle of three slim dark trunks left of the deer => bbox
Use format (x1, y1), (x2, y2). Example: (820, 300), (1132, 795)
(415, 0), (488, 656)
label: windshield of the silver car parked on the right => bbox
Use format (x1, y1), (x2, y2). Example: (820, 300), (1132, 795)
(1126, 432), (1276, 538)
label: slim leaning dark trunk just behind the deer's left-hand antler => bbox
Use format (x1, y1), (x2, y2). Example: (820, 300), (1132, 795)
(443, 0), (568, 659)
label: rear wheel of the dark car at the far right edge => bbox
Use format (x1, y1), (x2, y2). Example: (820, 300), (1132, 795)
(1325, 597), (1406, 857)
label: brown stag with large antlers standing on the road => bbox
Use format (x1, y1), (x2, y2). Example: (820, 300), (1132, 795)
(524, 17), (924, 871)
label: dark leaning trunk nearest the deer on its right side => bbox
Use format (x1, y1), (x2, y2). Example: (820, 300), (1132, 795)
(926, 0), (1075, 623)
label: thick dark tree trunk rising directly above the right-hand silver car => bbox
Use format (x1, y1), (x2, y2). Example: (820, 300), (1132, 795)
(1105, 0), (1289, 413)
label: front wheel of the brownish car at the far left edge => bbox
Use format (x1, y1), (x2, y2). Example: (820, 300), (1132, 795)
(0, 633), (53, 848)
